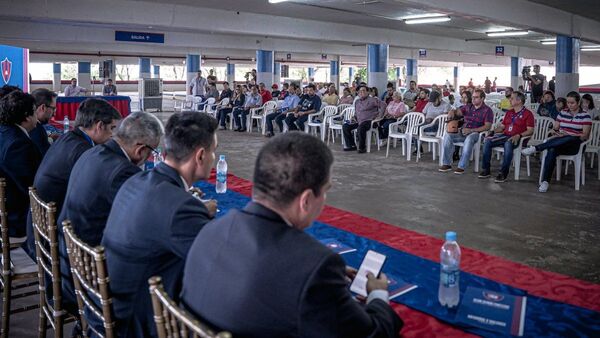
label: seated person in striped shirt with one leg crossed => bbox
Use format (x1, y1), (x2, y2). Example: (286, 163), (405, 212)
(523, 92), (592, 192)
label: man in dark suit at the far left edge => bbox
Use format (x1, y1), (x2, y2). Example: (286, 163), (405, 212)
(0, 90), (41, 237)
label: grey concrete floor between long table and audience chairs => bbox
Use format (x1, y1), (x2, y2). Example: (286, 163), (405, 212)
(2, 98), (600, 337)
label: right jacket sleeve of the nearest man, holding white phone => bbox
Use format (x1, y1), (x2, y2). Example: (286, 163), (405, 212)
(298, 253), (402, 338)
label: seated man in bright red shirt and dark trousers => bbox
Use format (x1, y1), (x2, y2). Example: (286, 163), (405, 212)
(479, 91), (535, 183)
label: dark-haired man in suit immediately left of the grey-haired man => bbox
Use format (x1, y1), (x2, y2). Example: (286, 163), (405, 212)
(26, 98), (121, 258)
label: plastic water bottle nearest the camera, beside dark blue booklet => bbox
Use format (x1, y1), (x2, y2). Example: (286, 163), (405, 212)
(438, 231), (460, 308)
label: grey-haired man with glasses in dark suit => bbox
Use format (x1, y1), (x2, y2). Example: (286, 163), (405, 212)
(58, 112), (164, 316)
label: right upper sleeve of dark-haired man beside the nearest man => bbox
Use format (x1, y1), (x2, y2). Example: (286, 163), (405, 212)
(169, 198), (210, 260)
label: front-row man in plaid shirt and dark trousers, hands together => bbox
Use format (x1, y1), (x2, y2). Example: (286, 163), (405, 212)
(342, 86), (385, 153)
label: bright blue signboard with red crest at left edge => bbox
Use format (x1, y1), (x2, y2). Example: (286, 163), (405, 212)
(0, 45), (29, 92)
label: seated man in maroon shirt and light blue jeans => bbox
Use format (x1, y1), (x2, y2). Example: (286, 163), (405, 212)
(439, 89), (494, 175)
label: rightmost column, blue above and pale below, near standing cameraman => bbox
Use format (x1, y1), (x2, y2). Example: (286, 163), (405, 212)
(556, 35), (580, 97)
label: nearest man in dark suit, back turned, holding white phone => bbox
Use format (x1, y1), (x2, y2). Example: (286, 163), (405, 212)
(181, 133), (402, 338)
